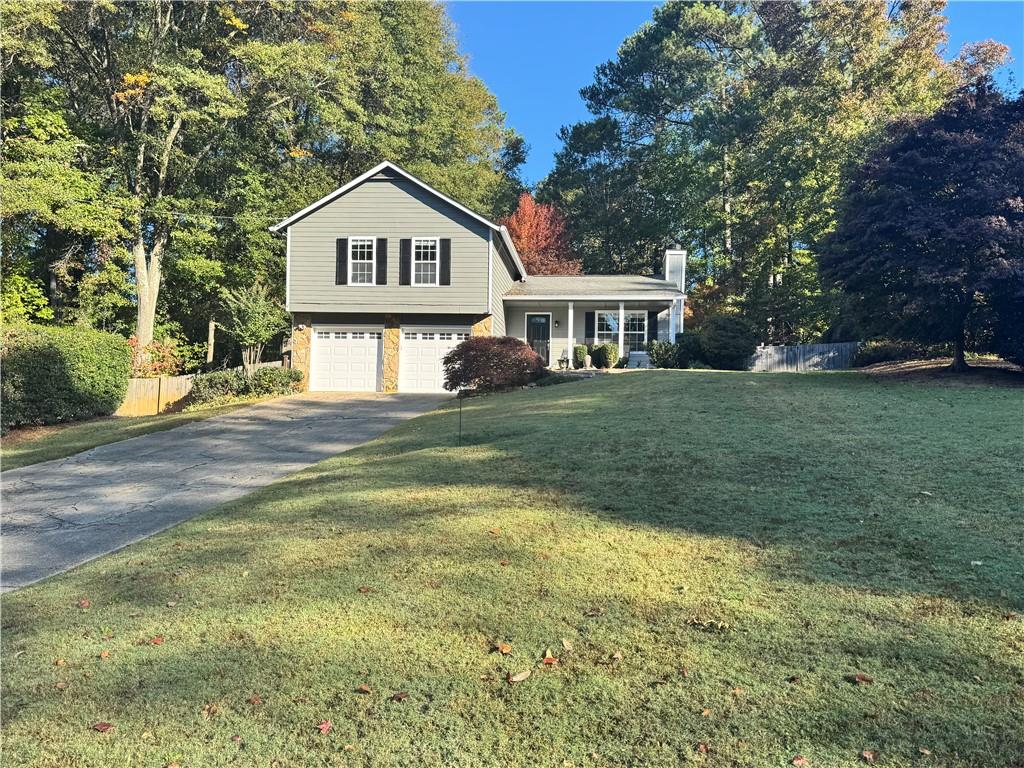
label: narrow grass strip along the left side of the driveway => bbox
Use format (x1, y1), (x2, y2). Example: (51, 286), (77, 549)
(0, 400), (253, 470)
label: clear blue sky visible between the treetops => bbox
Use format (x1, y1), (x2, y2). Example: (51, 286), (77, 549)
(447, 0), (1024, 183)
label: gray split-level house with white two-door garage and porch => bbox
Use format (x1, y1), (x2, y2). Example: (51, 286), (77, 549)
(270, 162), (685, 392)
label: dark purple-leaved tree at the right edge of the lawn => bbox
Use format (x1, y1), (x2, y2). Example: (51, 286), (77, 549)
(821, 82), (1024, 371)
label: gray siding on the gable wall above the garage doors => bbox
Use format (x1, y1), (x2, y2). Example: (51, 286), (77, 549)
(288, 177), (490, 314)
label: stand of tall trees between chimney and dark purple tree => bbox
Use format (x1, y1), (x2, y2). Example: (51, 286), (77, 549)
(541, 2), (955, 342)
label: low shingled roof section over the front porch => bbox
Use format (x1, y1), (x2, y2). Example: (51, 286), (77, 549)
(503, 274), (683, 301)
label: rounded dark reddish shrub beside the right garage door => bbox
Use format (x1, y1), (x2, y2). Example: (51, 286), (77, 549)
(444, 336), (548, 392)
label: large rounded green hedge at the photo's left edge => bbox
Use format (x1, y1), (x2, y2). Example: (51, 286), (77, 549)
(0, 326), (131, 432)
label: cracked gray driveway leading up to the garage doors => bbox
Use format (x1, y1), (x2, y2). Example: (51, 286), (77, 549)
(0, 393), (451, 590)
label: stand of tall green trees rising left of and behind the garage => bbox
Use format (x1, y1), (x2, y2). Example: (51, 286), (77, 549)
(0, 0), (524, 348)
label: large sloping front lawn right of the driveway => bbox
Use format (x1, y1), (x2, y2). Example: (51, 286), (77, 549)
(2, 371), (1024, 768)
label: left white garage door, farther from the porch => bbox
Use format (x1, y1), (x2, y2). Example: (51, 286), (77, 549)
(309, 326), (383, 392)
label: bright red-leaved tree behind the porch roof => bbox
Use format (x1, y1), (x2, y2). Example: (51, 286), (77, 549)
(502, 193), (583, 274)
